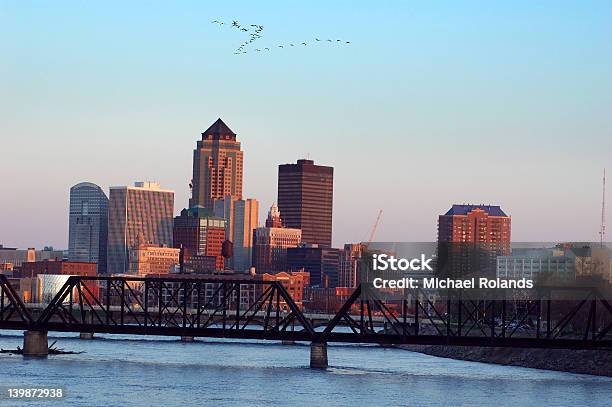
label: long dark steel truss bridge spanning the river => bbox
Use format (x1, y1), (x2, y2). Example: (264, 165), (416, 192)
(0, 275), (612, 349)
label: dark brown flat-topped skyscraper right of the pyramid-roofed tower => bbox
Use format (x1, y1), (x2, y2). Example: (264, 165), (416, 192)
(278, 160), (334, 247)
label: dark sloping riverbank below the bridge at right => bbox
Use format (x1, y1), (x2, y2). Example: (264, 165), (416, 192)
(399, 345), (612, 377)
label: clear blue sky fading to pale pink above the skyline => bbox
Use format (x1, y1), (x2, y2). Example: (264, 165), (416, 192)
(0, 0), (612, 248)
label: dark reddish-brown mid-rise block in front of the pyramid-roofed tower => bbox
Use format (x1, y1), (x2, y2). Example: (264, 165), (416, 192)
(173, 206), (225, 271)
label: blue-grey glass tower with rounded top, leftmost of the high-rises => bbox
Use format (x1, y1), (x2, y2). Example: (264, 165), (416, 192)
(68, 182), (108, 274)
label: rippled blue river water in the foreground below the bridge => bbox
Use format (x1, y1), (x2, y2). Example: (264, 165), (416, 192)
(0, 331), (612, 407)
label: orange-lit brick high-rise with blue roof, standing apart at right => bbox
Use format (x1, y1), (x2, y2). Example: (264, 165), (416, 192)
(437, 205), (511, 277)
